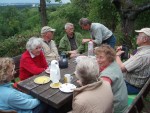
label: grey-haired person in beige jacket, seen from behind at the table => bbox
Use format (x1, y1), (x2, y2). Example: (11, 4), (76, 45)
(70, 57), (113, 113)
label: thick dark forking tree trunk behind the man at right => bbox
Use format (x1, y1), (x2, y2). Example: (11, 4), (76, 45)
(112, 0), (150, 47)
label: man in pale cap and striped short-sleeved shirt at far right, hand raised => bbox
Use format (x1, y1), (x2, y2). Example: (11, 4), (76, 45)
(116, 28), (150, 94)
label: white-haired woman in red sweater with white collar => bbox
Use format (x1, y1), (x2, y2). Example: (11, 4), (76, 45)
(19, 37), (48, 80)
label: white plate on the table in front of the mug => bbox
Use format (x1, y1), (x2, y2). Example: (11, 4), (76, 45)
(59, 83), (76, 93)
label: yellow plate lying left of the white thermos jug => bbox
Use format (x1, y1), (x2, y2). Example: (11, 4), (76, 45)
(34, 76), (50, 84)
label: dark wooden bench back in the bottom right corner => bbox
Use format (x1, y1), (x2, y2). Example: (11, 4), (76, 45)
(125, 78), (150, 113)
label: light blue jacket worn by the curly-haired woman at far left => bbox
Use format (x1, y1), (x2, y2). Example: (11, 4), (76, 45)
(0, 83), (40, 113)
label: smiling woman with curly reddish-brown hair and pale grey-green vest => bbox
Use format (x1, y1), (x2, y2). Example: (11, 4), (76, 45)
(95, 44), (128, 113)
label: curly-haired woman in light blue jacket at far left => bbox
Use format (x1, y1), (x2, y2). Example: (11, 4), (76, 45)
(0, 58), (46, 113)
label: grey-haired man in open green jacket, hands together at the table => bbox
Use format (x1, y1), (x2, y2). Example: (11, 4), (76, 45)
(59, 23), (84, 58)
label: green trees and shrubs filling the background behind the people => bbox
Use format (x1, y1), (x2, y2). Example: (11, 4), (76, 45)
(0, 0), (150, 56)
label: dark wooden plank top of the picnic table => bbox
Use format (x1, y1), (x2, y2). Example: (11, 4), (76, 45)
(18, 59), (78, 109)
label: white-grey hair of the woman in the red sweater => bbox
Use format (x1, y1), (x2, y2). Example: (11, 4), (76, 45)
(26, 37), (42, 52)
